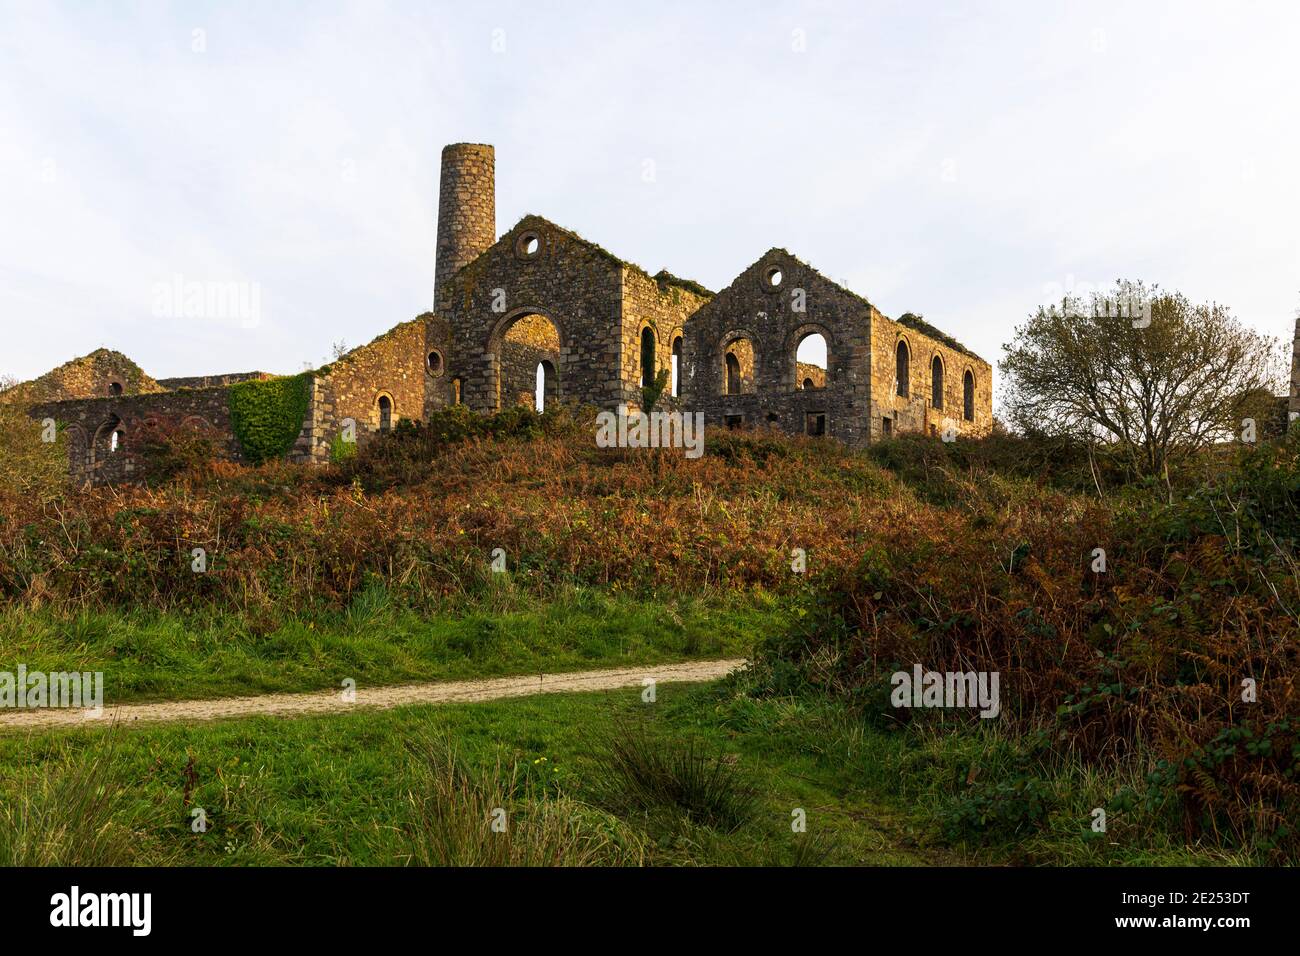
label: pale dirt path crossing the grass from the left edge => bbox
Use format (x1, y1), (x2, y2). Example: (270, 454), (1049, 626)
(0, 659), (745, 731)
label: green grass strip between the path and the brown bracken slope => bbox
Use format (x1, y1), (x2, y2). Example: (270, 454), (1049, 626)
(0, 589), (769, 705)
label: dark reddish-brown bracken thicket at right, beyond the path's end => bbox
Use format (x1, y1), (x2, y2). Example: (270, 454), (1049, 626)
(759, 438), (1300, 858)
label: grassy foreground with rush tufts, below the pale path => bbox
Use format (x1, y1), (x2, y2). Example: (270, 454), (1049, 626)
(0, 675), (1251, 866)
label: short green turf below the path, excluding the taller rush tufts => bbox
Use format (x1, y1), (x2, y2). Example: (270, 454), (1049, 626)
(0, 684), (933, 865)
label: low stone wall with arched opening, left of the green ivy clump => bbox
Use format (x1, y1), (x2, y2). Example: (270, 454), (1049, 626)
(29, 386), (243, 484)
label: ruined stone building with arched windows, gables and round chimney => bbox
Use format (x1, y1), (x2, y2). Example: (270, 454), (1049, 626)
(20, 143), (992, 480)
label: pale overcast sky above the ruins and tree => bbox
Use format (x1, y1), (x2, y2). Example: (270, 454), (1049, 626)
(0, 0), (1300, 392)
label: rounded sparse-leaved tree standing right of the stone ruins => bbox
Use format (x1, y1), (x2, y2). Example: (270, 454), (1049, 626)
(998, 282), (1281, 475)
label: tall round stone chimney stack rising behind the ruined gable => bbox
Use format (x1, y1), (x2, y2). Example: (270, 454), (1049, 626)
(433, 143), (497, 310)
